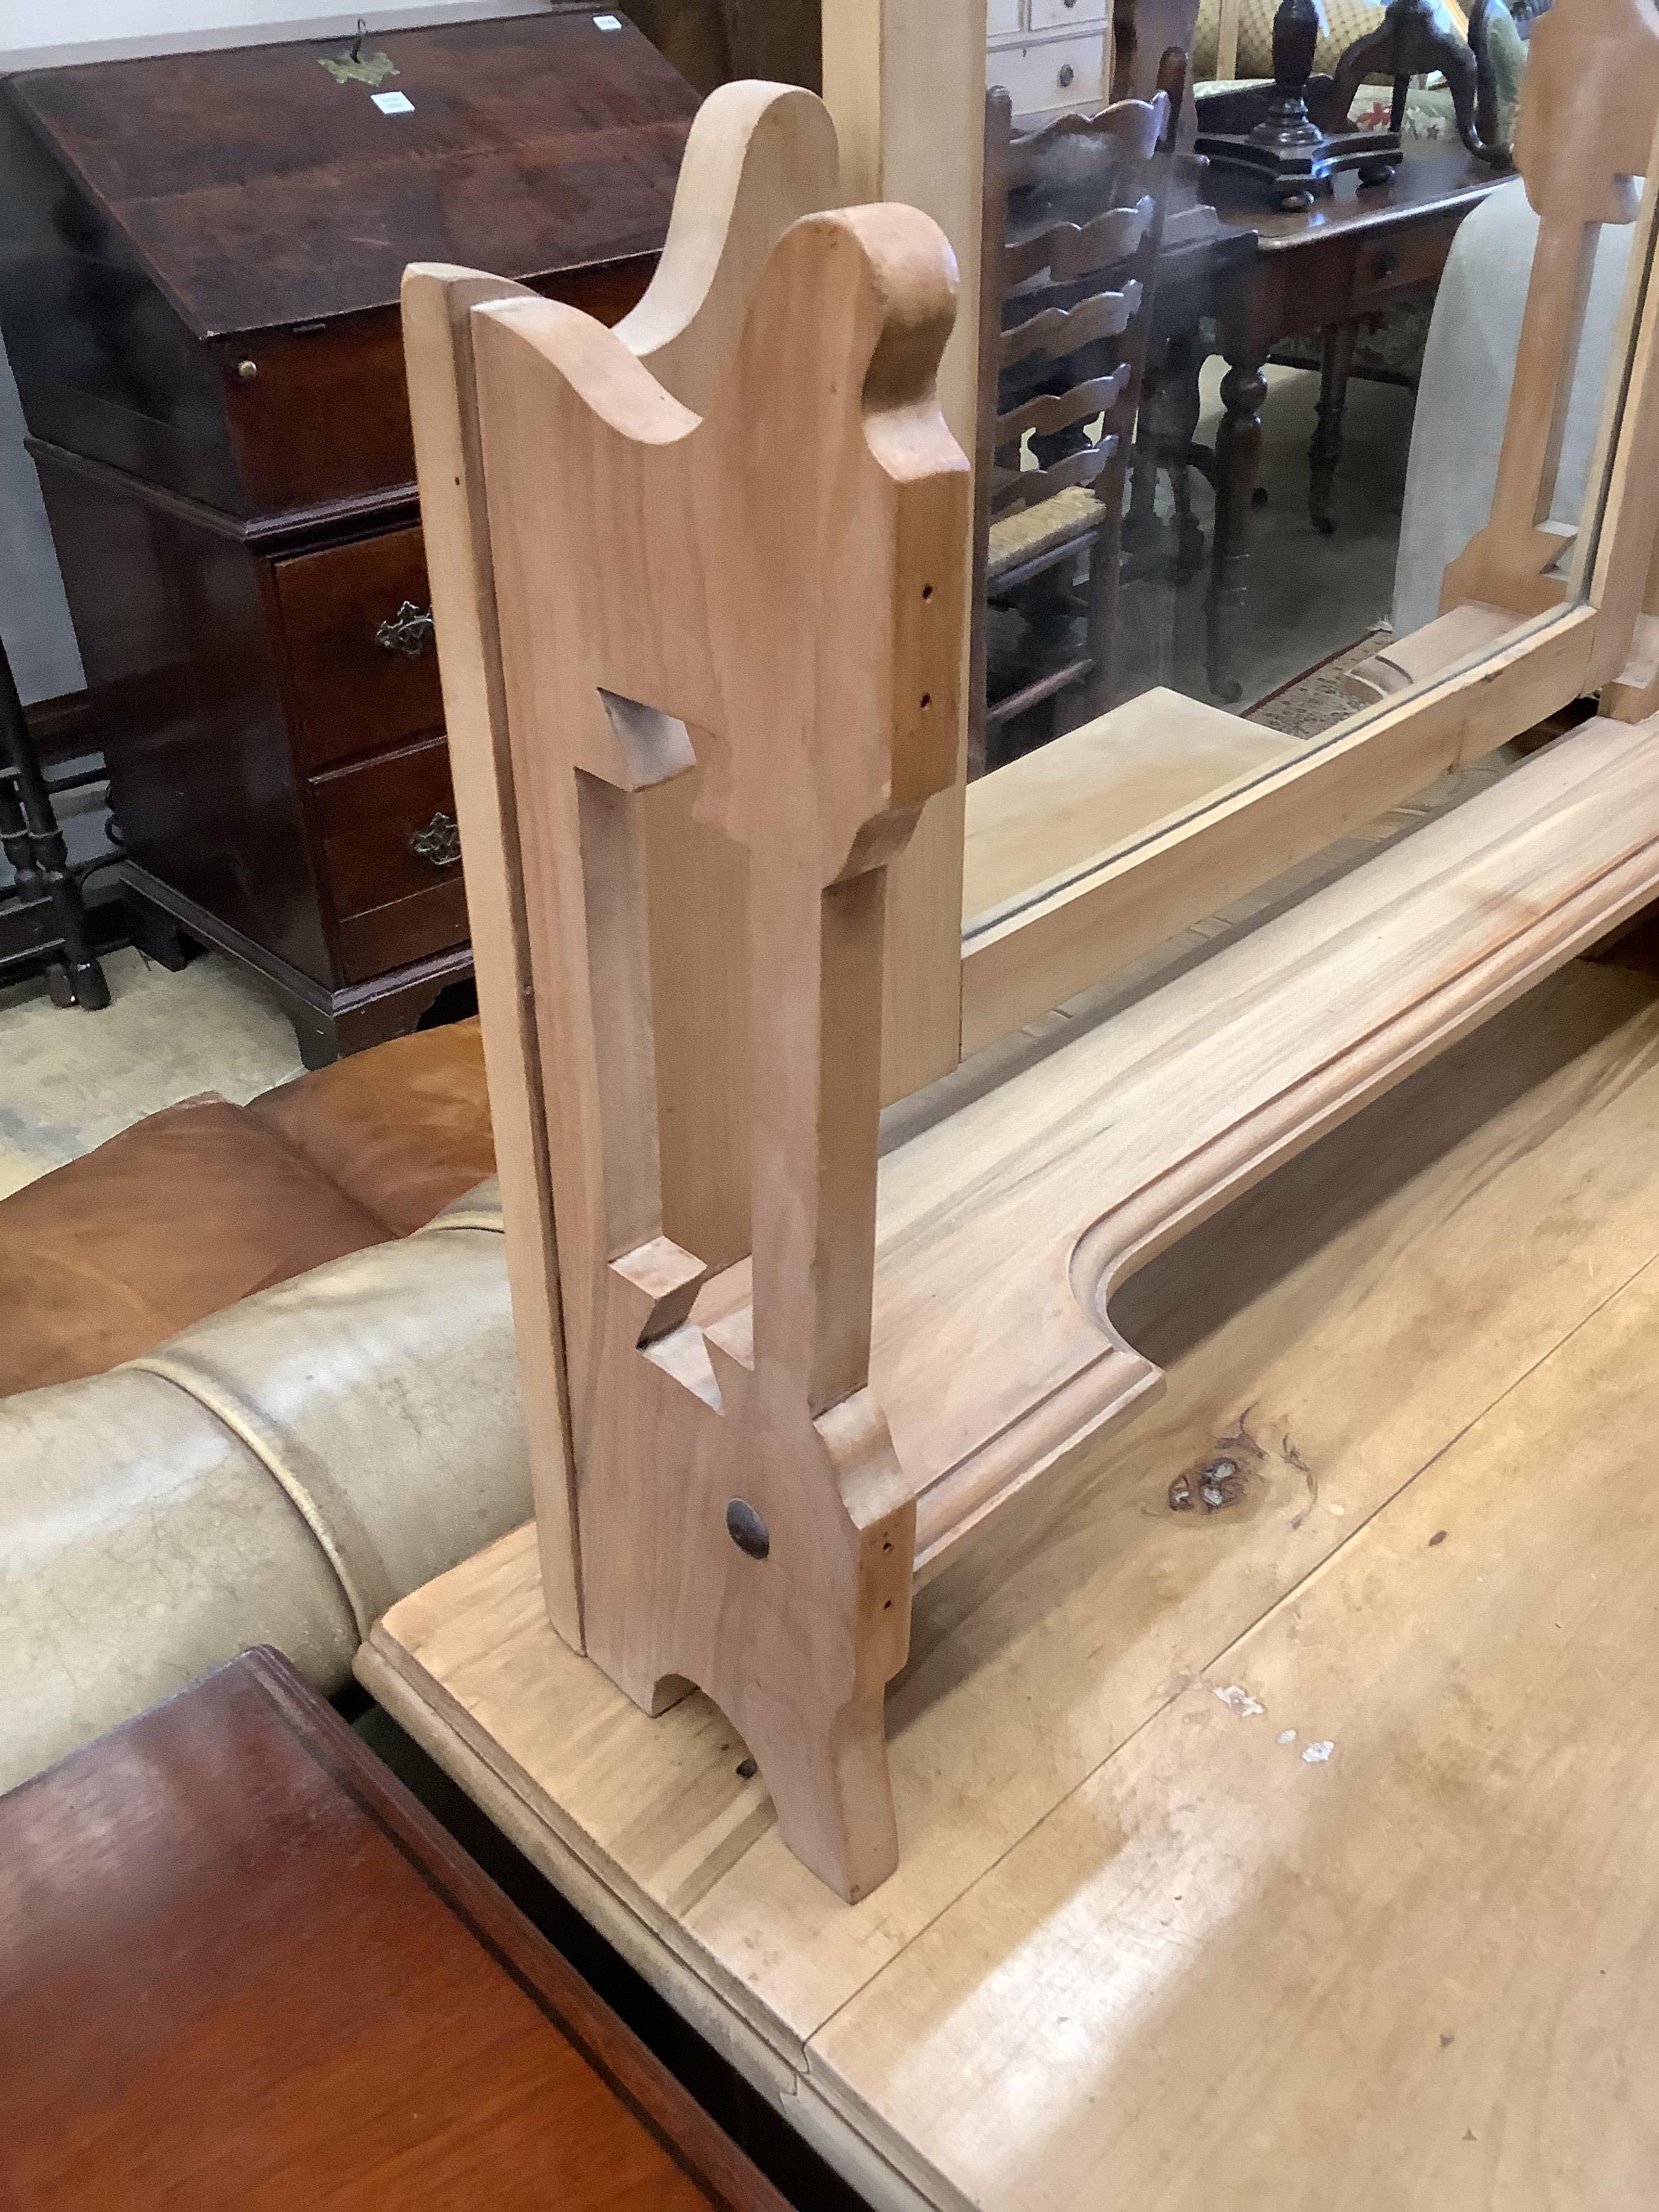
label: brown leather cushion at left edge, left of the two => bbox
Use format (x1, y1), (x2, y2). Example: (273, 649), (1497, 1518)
(0, 1092), (389, 1396)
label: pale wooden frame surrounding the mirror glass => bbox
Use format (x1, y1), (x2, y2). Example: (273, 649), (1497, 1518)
(844, 0), (1659, 1061)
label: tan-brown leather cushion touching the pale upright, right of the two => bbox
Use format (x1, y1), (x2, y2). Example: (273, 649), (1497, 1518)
(245, 1020), (495, 1241)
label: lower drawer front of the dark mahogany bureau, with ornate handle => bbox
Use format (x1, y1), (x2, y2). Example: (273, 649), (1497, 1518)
(310, 737), (467, 982)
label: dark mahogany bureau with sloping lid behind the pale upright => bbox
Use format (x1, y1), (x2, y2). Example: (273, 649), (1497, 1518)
(0, 7), (697, 1066)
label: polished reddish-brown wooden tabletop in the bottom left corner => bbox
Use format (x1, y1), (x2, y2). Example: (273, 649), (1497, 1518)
(0, 1650), (785, 2212)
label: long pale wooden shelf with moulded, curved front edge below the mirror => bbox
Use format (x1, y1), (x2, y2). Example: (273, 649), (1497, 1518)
(872, 721), (1659, 1579)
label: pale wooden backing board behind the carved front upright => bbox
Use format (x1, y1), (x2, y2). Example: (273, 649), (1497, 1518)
(403, 82), (838, 1650)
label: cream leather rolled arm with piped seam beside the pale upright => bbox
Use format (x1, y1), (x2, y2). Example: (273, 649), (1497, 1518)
(0, 1183), (531, 1790)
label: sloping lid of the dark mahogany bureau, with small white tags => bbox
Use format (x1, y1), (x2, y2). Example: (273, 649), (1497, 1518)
(7, 7), (697, 338)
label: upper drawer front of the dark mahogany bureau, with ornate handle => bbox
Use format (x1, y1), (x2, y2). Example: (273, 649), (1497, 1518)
(272, 525), (443, 768)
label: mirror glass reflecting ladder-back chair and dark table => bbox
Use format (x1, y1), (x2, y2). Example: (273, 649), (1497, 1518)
(962, 0), (1645, 945)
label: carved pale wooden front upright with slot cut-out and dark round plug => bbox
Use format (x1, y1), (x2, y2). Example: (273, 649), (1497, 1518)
(473, 208), (969, 1896)
